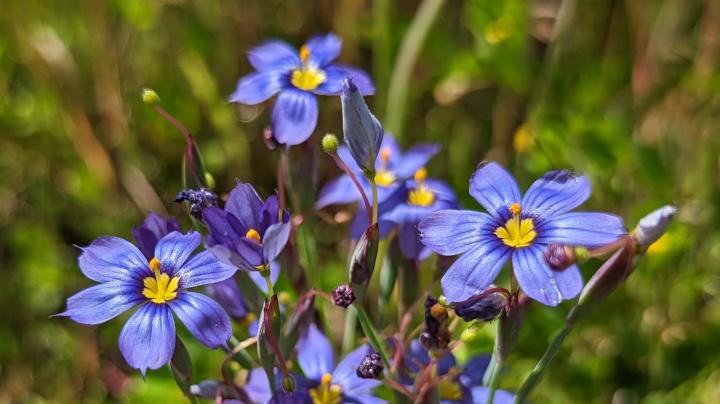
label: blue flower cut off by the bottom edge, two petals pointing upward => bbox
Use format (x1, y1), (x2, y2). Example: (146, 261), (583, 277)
(297, 324), (385, 404)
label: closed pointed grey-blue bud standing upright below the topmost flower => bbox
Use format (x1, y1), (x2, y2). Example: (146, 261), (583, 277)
(340, 79), (383, 172)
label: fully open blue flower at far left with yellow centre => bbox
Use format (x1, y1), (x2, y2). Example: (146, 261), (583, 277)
(58, 231), (236, 374)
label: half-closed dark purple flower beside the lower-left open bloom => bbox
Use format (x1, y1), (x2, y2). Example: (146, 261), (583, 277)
(203, 182), (290, 272)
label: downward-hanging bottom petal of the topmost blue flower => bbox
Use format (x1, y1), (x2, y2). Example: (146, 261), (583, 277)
(272, 89), (318, 146)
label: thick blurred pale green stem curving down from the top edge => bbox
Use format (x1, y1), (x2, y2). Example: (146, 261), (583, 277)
(385, 0), (445, 138)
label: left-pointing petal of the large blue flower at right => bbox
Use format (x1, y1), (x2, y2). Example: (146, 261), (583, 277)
(418, 210), (496, 256)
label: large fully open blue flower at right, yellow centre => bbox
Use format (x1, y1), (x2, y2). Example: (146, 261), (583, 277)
(418, 162), (626, 306)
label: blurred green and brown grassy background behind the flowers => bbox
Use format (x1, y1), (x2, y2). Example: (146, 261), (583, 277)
(0, 0), (720, 403)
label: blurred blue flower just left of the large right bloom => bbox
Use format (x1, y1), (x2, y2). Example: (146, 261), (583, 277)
(382, 168), (458, 260)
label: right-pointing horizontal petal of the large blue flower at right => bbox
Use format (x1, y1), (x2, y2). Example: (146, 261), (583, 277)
(537, 212), (627, 247)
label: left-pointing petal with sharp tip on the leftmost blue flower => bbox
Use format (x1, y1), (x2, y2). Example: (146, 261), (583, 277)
(57, 281), (144, 325)
